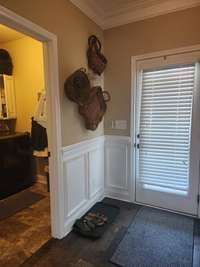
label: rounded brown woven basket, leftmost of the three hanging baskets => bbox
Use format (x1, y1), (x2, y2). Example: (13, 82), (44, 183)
(64, 68), (90, 105)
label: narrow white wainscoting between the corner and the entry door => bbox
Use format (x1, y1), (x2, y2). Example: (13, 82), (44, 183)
(105, 136), (132, 201)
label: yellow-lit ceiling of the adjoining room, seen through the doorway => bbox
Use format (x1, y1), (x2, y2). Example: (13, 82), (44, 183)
(0, 24), (25, 43)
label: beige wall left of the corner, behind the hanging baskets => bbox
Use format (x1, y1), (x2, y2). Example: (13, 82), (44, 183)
(0, 0), (103, 146)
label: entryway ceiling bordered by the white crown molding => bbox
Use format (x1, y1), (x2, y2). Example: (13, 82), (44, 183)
(70, 0), (200, 29)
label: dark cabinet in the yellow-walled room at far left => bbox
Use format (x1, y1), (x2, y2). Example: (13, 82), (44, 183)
(0, 133), (35, 199)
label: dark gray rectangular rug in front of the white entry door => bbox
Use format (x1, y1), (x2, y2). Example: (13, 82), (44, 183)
(111, 207), (194, 267)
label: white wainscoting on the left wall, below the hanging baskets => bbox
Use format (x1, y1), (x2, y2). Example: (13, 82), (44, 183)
(62, 136), (104, 234)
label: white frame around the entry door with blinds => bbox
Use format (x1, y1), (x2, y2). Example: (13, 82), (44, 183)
(130, 44), (200, 218)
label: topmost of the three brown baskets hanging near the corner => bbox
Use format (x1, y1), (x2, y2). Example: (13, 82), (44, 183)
(87, 35), (107, 75)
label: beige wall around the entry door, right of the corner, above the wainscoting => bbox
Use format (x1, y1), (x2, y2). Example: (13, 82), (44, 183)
(104, 7), (200, 135)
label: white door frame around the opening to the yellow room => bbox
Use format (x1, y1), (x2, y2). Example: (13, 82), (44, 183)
(0, 5), (64, 238)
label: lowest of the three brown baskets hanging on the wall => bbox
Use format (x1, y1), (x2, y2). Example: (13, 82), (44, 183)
(79, 86), (110, 131)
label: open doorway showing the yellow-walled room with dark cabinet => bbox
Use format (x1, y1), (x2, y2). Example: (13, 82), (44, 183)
(0, 24), (51, 267)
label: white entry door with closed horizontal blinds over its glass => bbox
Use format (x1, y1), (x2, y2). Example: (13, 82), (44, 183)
(135, 52), (200, 215)
